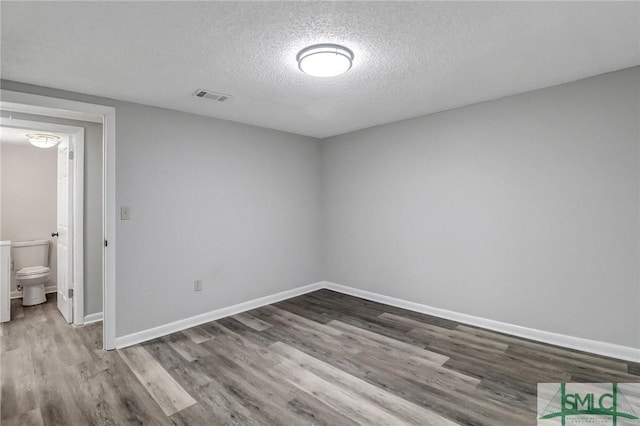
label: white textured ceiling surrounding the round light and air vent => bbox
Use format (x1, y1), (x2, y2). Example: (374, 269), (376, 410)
(0, 1), (640, 137)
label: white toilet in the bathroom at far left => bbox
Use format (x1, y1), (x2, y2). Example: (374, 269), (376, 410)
(11, 240), (51, 306)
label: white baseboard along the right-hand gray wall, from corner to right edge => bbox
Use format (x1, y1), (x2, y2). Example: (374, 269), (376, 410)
(324, 282), (640, 362)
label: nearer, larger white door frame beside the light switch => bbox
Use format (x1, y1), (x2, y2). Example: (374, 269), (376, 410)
(0, 90), (116, 349)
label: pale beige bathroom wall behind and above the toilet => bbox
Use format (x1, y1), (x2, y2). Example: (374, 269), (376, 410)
(0, 141), (58, 292)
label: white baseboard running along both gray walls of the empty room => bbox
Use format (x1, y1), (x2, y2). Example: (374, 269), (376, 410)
(111, 281), (640, 362)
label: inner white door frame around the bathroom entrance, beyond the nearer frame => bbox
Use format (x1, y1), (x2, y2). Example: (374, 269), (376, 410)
(0, 117), (84, 325)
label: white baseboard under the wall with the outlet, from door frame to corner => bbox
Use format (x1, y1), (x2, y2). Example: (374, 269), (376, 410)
(116, 282), (324, 349)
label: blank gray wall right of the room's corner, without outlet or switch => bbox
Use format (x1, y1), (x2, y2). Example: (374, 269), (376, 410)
(322, 68), (640, 347)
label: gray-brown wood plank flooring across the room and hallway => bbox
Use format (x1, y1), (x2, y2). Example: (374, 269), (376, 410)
(0, 290), (640, 426)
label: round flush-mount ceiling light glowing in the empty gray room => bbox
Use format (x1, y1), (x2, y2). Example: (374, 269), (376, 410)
(296, 44), (353, 77)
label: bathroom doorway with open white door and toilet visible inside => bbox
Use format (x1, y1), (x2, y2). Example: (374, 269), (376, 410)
(0, 116), (88, 325)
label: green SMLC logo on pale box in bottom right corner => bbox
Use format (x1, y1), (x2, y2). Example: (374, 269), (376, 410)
(538, 383), (640, 426)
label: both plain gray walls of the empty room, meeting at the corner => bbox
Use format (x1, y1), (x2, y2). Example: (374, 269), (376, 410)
(2, 68), (640, 346)
